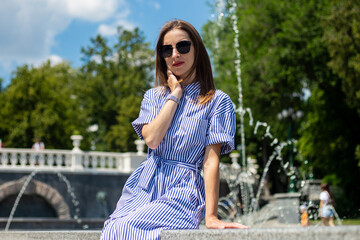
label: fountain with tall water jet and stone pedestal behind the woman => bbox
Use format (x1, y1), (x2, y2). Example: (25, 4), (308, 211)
(213, 0), (341, 226)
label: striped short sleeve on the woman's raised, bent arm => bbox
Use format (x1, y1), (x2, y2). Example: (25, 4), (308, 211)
(131, 89), (158, 140)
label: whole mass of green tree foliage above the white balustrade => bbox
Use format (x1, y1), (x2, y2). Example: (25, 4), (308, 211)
(0, 28), (153, 152)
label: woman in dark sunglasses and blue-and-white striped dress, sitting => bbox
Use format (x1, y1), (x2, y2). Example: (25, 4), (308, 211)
(102, 20), (247, 240)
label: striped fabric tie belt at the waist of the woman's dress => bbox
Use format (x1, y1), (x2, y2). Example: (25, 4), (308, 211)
(138, 153), (201, 190)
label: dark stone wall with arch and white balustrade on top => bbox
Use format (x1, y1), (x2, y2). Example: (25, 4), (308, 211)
(0, 136), (146, 233)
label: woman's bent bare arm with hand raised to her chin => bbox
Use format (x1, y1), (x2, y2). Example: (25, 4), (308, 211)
(142, 72), (182, 149)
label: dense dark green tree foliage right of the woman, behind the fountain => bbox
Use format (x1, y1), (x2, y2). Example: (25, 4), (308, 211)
(203, 0), (360, 216)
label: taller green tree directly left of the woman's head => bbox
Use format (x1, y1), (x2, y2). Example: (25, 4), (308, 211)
(77, 28), (154, 151)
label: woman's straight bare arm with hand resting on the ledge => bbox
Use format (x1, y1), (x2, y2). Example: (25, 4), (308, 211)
(204, 143), (248, 229)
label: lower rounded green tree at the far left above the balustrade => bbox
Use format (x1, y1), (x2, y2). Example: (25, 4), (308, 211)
(0, 61), (83, 149)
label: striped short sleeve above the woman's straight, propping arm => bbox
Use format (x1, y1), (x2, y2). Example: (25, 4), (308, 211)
(205, 93), (236, 154)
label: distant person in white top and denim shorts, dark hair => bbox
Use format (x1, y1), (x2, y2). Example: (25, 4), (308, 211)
(319, 183), (335, 227)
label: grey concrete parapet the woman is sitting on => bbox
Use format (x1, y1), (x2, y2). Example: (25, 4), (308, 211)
(0, 226), (360, 240)
